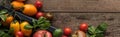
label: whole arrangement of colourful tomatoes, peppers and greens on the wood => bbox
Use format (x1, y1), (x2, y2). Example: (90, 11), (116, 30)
(0, 0), (108, 37)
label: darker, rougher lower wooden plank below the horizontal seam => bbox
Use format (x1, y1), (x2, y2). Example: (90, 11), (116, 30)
(52, 13), (120, 37)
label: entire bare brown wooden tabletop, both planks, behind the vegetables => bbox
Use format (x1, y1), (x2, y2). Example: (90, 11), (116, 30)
(27, 0), (120, 37)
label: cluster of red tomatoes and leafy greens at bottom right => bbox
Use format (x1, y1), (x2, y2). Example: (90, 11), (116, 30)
(62, 22), (108, 37)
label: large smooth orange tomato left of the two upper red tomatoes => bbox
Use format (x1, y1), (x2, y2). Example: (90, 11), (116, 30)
(23, 4), (37, 16)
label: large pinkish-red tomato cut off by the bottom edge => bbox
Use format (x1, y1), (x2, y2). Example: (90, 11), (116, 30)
(33, 30), (52, 37)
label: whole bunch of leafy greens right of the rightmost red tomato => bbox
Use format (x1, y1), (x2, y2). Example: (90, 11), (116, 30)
(87, 22), (108, 37)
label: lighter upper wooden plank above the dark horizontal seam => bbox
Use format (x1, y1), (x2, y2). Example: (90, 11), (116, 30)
(28, 0), (120, 12)
